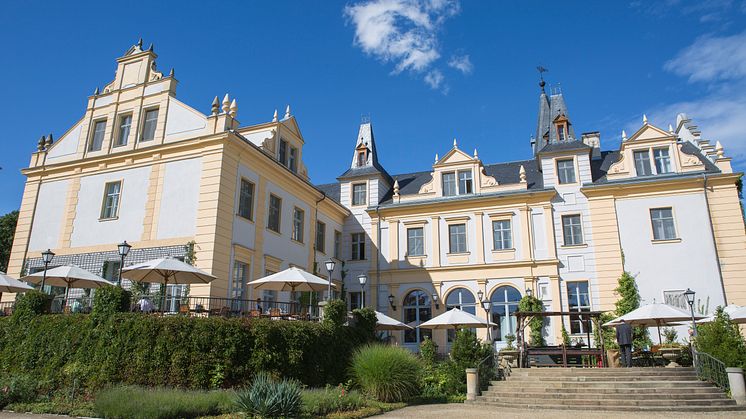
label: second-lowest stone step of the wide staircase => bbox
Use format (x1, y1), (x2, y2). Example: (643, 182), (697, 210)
(482, 389), (730, 401)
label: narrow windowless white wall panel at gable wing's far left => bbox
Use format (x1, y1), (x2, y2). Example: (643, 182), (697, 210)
(28, 180), (70, 252)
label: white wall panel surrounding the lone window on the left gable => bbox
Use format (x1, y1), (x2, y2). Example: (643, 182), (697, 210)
(70, 166), (151, 247)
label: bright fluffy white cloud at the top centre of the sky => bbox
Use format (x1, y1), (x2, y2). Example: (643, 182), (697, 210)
(344, 0), (460, 89)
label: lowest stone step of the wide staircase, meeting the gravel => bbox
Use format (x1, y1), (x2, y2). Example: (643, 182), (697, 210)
(466, 399), (746, 413)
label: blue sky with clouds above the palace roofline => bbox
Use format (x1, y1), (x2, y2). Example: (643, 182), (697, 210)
(0, 0), (746, 213)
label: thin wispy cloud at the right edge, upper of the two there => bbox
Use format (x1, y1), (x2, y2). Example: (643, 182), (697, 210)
(663, 32), (746, 82)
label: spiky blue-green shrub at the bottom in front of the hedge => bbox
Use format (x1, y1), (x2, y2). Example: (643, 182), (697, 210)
(236, 372), (303, 418)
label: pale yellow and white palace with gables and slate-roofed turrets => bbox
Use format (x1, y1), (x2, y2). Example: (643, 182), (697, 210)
(3, 42), (746, 350)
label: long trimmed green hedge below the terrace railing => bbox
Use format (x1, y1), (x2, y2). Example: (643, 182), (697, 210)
(0, 313), (373, 389)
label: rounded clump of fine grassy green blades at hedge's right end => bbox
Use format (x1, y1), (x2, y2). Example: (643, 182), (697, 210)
(351, 345), (422, 402)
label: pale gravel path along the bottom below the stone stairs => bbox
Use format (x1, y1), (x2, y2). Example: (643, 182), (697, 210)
(376, 403), (746, 419)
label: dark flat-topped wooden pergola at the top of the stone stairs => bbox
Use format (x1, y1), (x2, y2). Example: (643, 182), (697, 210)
(515, 311), (607, 368)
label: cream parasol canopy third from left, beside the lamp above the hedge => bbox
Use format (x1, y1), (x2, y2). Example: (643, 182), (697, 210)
(122, 257), (215, 285)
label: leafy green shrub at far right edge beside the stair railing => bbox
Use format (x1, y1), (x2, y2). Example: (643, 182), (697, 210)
(694, 307), (746, 368)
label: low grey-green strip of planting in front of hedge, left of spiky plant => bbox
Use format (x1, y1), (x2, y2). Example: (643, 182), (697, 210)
(94, 386), (232, 419)
